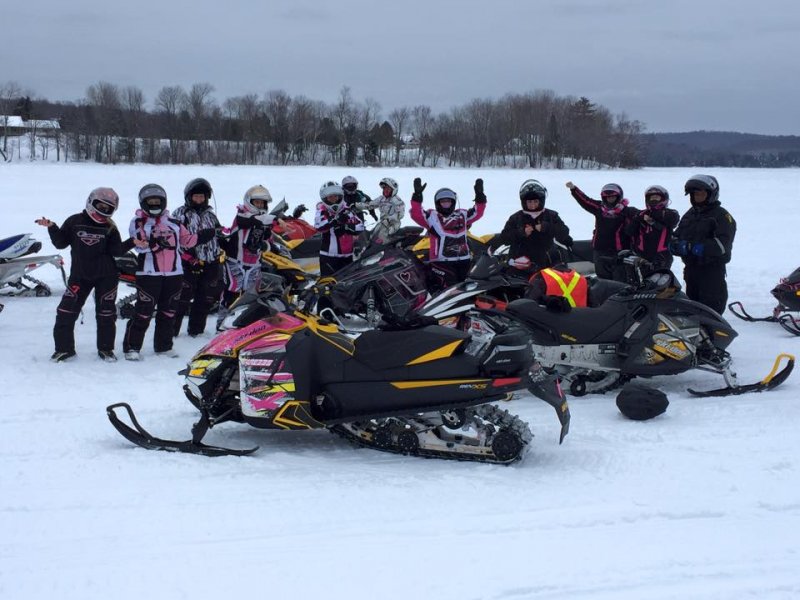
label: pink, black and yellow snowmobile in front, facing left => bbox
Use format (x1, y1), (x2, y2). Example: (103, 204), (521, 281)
(107, 300), (570, 464)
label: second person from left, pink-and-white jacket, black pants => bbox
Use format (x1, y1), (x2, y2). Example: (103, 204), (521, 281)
(122, 183), (216, 360)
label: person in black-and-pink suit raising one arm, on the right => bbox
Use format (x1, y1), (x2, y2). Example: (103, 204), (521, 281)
(567, 181), (637, 282)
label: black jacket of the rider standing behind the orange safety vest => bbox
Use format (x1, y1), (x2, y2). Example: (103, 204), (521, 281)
(490, 208), (572, 271)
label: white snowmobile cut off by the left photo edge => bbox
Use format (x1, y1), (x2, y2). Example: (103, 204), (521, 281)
(0, 233), (67, 296)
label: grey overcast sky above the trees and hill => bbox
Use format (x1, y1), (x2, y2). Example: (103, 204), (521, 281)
(0, 0), (800, 135)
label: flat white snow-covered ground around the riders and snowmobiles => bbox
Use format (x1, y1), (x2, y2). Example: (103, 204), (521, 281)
(0, 164), (800, 600)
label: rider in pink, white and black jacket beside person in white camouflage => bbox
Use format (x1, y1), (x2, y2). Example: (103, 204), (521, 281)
(314, 181), (364, 277)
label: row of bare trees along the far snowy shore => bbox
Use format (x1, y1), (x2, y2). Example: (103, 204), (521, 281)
(0, 81), (644, 168)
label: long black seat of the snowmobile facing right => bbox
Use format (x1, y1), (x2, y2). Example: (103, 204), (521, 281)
(506, 298), (627, 345)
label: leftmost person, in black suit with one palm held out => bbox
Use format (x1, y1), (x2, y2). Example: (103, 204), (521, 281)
(35, 187), (132, 362)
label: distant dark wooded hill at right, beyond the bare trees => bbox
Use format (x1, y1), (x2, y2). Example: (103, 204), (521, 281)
(639, 131), (800, 167)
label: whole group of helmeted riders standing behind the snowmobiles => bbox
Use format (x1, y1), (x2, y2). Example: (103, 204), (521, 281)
(36, 175), (736, 362)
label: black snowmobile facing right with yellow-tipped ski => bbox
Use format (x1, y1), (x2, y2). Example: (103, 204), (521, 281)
(506, 264), (794, 396)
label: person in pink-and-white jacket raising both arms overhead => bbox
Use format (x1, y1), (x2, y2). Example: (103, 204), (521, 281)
(411, 177), (486, 294)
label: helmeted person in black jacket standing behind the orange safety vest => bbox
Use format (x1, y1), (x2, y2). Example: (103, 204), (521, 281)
(490, 179), (572, 277)
